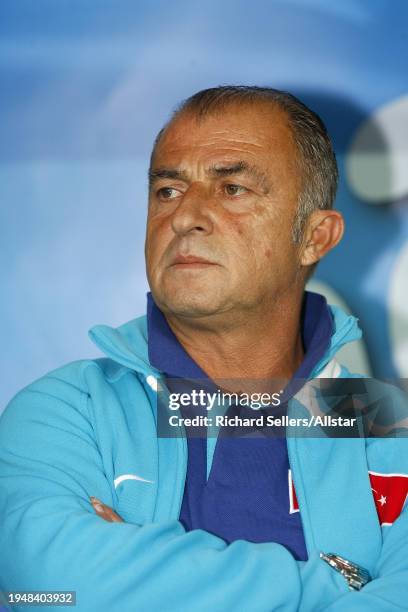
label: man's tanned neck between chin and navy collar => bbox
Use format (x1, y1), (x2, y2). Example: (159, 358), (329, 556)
(166, 289), (304, 382)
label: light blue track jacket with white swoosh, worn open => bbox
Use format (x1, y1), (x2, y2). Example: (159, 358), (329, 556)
(0, 307), (408, 612)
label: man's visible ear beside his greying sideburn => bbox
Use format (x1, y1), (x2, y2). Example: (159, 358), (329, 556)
(300, 210), (344, 266)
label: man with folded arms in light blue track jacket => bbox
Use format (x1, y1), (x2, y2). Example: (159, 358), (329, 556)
(0, 87), (408, 611)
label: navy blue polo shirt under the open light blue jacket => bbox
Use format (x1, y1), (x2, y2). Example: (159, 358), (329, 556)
(147, 292), (334, 560)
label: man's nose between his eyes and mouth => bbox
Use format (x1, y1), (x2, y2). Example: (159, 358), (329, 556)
(171, 185), (213, 236)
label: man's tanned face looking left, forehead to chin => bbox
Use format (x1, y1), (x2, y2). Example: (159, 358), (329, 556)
(146, 104), (300, 317)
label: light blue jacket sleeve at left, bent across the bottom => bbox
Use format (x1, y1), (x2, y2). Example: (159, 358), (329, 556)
(0, 383), (343, 612)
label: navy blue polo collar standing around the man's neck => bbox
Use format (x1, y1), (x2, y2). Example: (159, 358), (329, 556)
(147, 291), (334, 379)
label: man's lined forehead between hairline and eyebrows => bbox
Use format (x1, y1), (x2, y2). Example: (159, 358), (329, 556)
(153, 103), (297, 166)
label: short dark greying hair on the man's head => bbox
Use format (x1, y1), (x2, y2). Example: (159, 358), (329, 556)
(151, 85), (338, 244)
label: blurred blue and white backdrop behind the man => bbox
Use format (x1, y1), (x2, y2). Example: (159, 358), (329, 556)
(0, 0), (408, 411)
